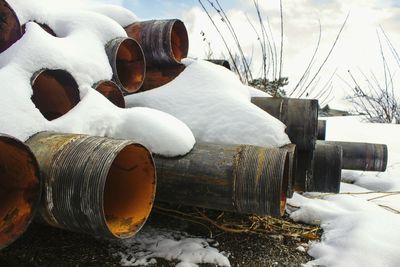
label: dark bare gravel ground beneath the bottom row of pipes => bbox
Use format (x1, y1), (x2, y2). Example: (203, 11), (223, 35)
(0, 210), (312, 267)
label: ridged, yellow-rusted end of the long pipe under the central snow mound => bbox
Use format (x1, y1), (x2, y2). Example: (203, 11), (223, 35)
(234, 146), (290, 217)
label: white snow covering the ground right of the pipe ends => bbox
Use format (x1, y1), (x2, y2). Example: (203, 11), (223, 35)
(288, 117), (400, 266)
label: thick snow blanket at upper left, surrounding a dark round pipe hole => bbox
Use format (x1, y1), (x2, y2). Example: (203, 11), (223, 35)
(0, 0), (195, 156)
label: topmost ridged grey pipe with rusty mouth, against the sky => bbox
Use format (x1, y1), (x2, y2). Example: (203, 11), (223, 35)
(125, 19), (189, 66)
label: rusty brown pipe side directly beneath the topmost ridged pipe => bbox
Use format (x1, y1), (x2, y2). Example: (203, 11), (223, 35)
(140, 64), (185, 91)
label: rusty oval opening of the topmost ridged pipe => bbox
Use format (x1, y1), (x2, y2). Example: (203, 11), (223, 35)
(171, 20), (189, 62)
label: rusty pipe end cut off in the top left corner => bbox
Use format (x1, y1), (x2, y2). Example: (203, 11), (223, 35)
(0, 0), (22, 53)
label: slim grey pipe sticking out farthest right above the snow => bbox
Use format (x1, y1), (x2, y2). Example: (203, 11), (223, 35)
(318, 141), (388, 172)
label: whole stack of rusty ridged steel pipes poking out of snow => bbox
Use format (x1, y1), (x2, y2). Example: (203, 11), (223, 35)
(0, 0), (387, 249)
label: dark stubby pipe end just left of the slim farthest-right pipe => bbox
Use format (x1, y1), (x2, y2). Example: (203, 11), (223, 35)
(307, 143), (343, 193)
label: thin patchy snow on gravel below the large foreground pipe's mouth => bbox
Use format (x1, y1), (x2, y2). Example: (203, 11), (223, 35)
(111, 227), (231, 267)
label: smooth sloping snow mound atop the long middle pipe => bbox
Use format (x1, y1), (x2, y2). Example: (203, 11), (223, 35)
(125, 59), (290, 147)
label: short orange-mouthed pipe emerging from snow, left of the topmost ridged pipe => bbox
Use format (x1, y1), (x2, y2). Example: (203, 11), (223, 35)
(105, 37), (146, 94)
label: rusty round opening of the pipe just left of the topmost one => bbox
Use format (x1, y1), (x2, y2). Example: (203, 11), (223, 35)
(115, 39), (146, 93)
